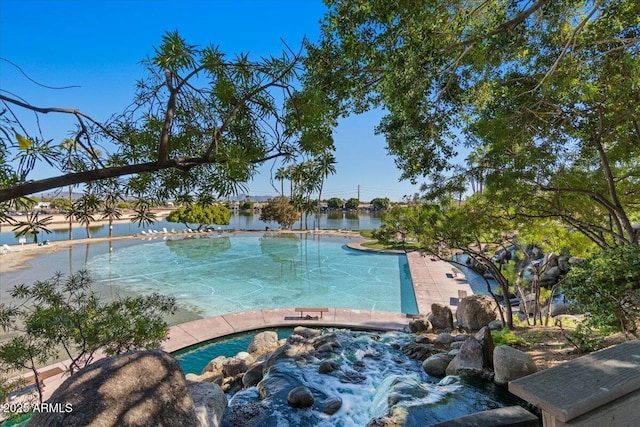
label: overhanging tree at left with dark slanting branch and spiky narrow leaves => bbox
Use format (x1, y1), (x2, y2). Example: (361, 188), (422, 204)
(0, 32), (333, 211)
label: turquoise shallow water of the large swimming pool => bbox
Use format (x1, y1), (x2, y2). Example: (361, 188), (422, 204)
(87, 233), (417, 316)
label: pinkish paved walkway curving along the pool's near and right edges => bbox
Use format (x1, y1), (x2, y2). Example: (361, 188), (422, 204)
(11, 242), (473, 399)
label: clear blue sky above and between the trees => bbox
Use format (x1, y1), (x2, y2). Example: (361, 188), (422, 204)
(0, 0), (424, 201)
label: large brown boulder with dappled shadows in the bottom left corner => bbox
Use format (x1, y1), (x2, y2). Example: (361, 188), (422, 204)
(28, 350), (198, 427)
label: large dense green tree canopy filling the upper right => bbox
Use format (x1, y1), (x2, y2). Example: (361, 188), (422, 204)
(306, 0), (640, 248)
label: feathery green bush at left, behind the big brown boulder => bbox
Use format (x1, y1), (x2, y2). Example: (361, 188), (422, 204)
(0, 271), (176, 401)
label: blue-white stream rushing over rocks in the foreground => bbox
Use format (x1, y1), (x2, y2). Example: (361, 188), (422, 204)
(188, 328), (516, 427)
